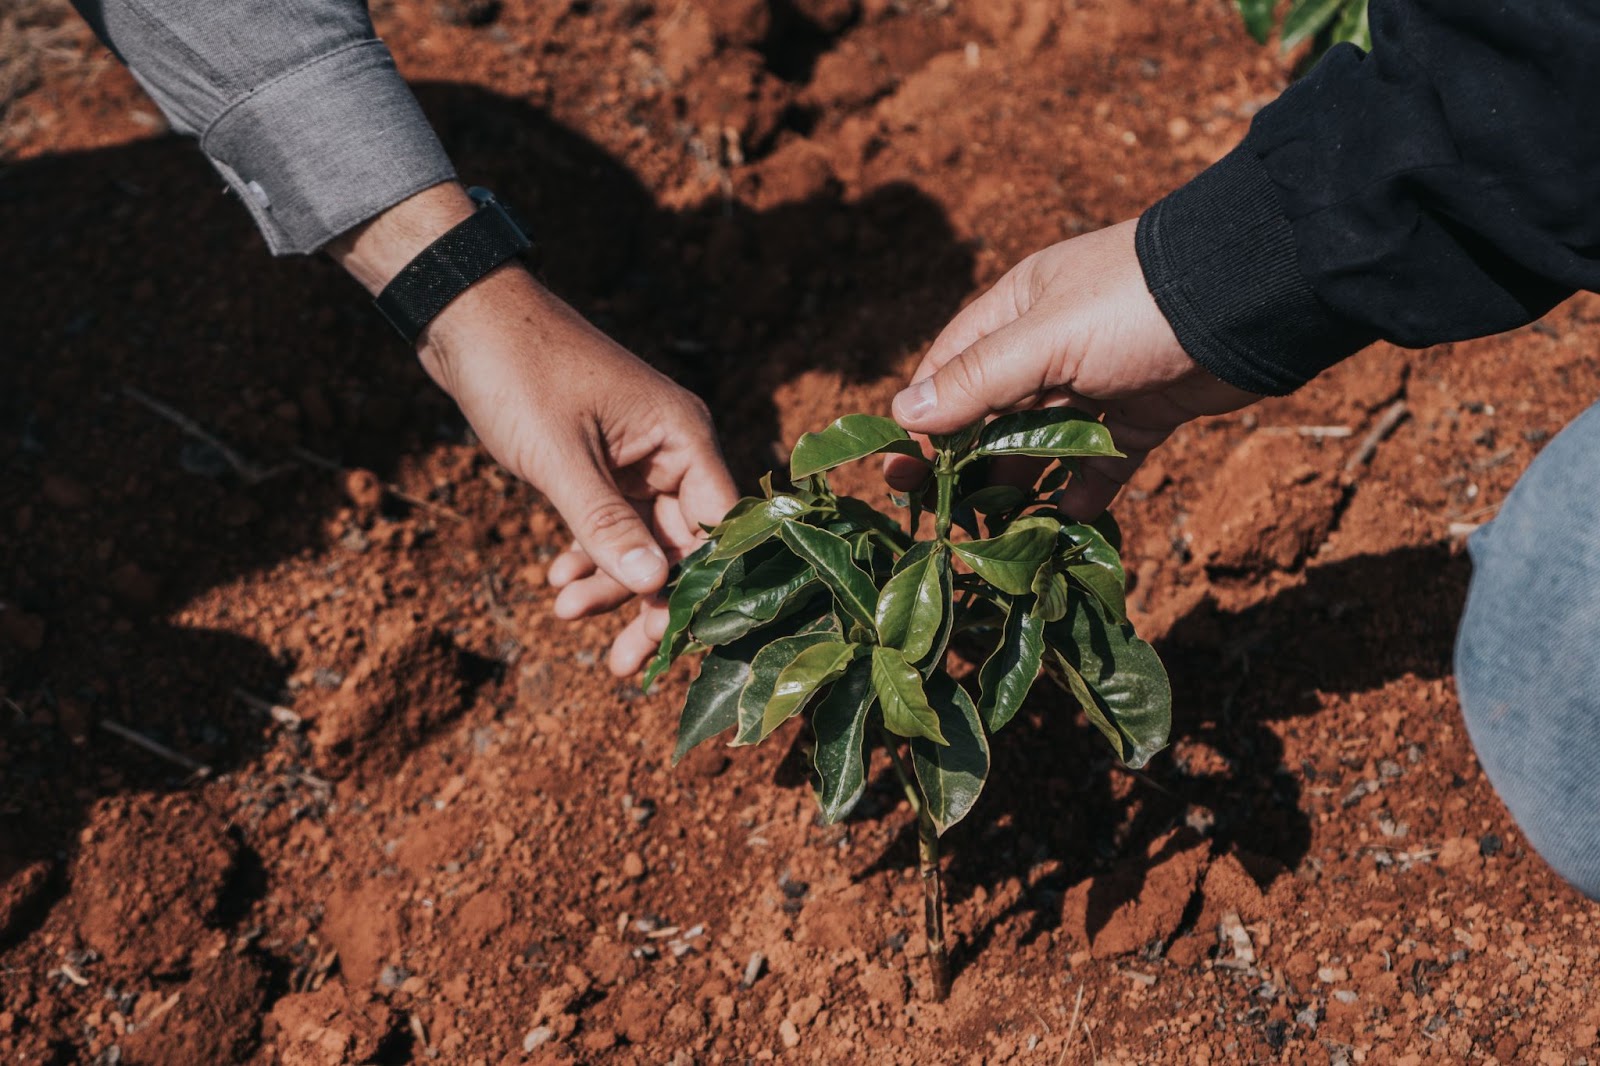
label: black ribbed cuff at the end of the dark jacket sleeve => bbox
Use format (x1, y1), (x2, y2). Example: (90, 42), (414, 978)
(1134, 141), (1378, 395)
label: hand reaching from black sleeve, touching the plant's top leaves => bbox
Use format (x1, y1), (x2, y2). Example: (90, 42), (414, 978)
(885, 221), (1261, 519)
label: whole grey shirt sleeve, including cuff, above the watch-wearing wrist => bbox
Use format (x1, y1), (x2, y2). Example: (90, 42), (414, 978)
(74, 0), (454, 254)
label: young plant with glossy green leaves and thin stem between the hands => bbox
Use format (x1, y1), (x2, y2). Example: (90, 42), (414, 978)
(645, 408), (1171, 1000)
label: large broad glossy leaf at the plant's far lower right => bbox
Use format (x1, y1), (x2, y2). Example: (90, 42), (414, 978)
(1045, 595), (1173, 768)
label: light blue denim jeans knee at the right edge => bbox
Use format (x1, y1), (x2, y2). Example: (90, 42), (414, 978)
(1456, 405), (1600, 898)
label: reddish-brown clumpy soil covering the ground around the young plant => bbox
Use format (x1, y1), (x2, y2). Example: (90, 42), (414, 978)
(0, 0), (1600, 1064)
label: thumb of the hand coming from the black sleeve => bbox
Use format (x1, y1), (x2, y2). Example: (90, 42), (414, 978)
(894, 315), (1058, 434)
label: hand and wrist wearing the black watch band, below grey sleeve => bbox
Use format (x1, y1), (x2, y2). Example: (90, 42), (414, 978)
(330, 184), (738, 675)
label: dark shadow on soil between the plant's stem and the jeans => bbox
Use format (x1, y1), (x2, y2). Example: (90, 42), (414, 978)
(866, 544), (1469, 970)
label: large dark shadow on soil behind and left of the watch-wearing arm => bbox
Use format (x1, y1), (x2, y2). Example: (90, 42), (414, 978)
(0, 85), (971, 948)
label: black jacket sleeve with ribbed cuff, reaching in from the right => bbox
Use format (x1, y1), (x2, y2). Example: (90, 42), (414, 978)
(1138, 0), (1600, 394)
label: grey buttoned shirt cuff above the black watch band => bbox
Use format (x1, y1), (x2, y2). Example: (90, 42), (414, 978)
(200, 40), (454, 254)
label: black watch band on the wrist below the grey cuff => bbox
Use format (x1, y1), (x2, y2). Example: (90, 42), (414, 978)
(373, 186), (533, 344)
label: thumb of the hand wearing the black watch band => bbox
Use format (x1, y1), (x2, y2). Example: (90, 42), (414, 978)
(544, 455), (667, 594)
